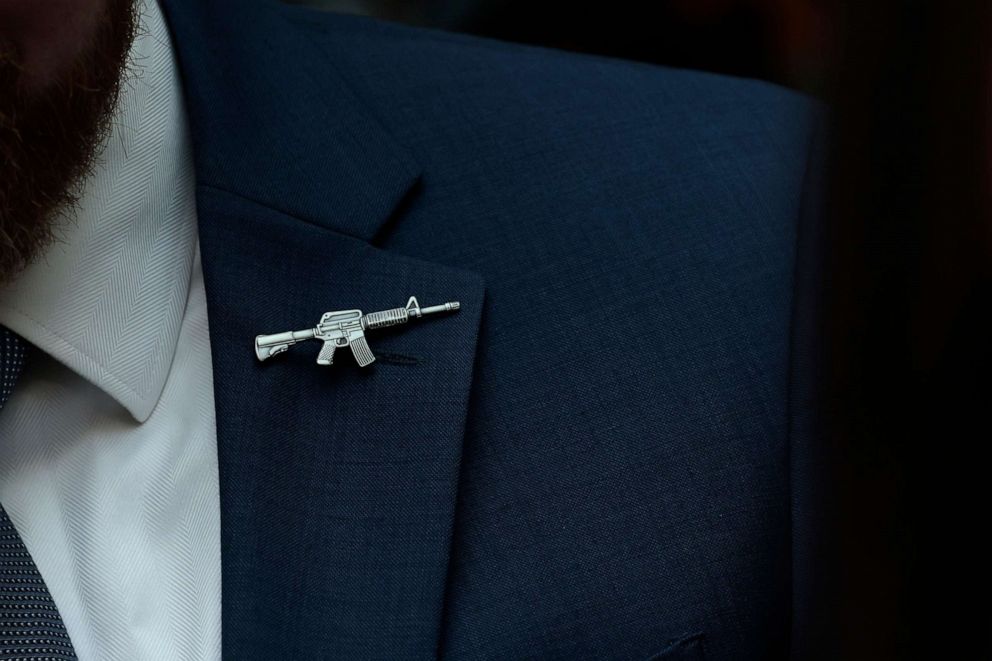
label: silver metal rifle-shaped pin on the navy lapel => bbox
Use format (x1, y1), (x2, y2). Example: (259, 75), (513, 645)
(255, 296), (461, 367)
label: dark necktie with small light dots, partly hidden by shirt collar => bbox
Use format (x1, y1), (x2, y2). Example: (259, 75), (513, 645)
(0, 326), (76, 661)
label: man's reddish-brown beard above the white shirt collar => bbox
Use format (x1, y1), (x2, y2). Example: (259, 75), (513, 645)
(0, 0), (137, 283)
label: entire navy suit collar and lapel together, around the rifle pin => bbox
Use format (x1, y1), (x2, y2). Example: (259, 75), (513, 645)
(164, 0), (483, 659)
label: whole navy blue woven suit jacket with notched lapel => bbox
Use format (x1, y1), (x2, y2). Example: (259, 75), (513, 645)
(163, 0), (814, 660)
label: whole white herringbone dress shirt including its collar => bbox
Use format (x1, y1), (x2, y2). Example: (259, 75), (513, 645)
(0, 0), (221, 661)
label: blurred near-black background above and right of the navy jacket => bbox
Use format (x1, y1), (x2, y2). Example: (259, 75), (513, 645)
(282, 0), (992, 660)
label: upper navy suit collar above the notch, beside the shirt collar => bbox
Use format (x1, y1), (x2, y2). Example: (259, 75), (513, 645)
(163, 0), (420, 240)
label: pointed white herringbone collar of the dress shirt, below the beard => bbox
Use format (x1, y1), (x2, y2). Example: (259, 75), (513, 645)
(0, 0), (196, 422)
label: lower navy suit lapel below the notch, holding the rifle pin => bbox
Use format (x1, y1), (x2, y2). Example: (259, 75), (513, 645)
(199, 189), (482, 659)
